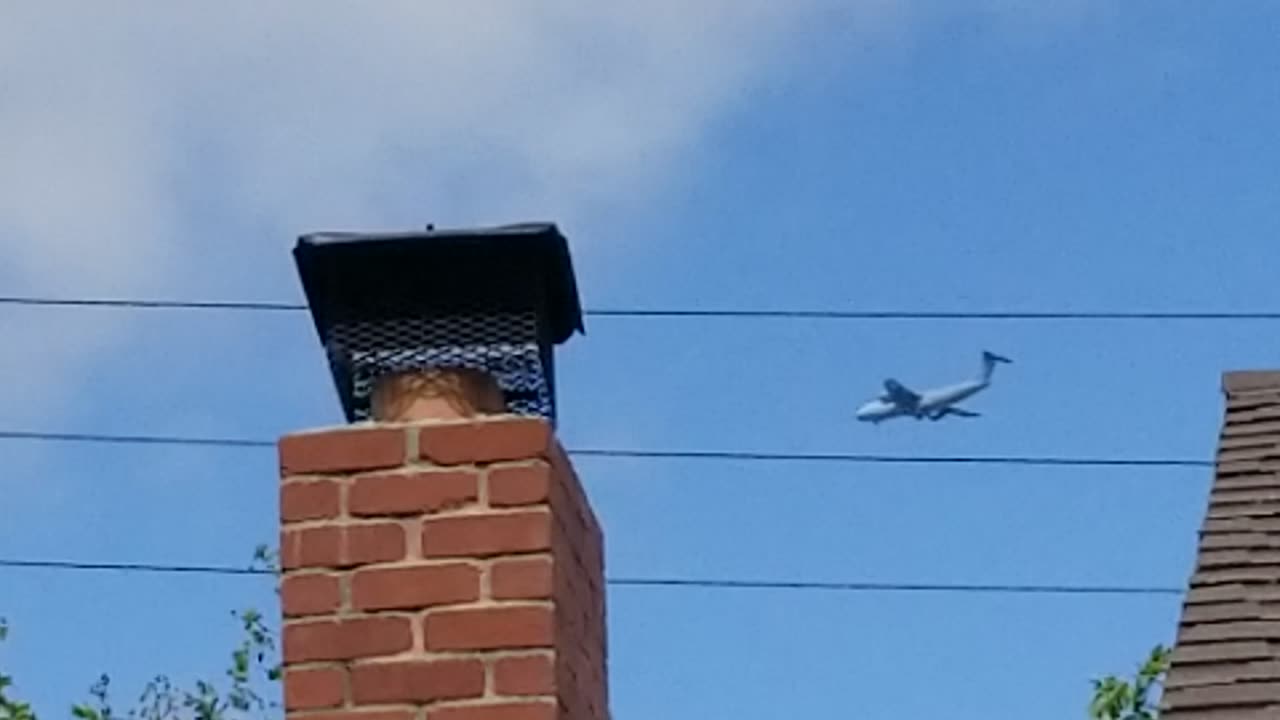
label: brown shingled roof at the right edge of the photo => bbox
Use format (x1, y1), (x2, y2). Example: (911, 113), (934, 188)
(1161, 372), (1280, 720)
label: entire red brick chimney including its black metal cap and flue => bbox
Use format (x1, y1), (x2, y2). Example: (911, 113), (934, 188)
(279, 223), (596, 720)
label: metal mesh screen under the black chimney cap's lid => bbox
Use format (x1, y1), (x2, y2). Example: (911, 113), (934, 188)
(326, 311), (554, 420)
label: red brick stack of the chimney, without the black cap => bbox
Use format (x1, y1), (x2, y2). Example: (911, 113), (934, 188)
(279, 412), (608, 720)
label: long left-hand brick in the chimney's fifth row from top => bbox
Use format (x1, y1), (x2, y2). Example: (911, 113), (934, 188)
(283, 618), (413, 664)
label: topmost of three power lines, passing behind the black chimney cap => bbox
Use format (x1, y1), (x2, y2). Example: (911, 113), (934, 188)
(0, 296), (1280, 320)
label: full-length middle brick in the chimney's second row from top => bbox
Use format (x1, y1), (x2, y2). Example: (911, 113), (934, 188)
(347, 470), (479, 516)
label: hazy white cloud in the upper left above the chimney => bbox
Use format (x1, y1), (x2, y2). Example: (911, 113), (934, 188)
(0, 0), (1100, 423)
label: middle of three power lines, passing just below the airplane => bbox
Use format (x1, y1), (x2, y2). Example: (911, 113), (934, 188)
(0, 430), (1215, 468)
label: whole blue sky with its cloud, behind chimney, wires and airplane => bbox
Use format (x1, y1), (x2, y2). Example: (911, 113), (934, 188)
(0, 0), (1280, 720)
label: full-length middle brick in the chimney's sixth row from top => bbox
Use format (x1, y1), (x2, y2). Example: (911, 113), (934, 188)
(351, 660), (484, 705)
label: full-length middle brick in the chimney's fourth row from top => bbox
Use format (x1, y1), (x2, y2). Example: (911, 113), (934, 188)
(351, 562), (480, 610)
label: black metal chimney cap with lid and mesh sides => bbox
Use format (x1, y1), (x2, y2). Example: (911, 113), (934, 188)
(293, 223), (585, 421)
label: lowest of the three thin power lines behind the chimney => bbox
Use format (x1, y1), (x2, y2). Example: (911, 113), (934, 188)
(0, 560), (1184, 596)
